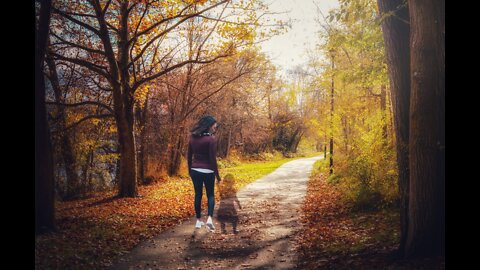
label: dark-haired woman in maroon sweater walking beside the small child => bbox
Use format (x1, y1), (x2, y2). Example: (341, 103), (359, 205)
(187, 115), (221, 231)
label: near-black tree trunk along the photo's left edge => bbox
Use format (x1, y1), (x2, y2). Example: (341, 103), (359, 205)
(35, 0), (55, 235)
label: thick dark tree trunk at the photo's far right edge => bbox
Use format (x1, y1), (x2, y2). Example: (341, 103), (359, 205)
(405, 0), (445, 257)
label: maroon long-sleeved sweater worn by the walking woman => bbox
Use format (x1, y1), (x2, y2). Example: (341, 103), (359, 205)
(187, 135), (220, 180)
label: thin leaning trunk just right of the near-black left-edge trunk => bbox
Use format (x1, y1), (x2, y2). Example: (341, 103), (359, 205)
(45, 54), (78, 199)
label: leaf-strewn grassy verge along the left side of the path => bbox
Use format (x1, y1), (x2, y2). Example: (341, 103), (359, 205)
(35, 153), (316, 269)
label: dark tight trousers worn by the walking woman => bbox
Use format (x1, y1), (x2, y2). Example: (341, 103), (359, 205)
(190, 170), (215, 218)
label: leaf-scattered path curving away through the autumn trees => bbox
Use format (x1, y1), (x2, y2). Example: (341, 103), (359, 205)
(110, 156), (321, 270)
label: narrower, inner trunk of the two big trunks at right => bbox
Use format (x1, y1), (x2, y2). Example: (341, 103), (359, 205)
(378, 0), (410, 255)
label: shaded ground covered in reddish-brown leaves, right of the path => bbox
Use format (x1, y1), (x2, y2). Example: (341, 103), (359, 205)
(297, 163), (445, 269)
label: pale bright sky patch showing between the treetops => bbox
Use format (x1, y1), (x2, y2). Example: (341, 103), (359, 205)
(262, 0), (338, 77)
